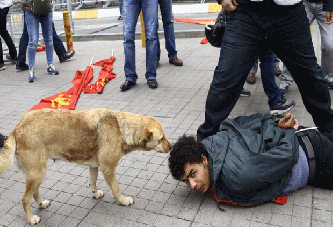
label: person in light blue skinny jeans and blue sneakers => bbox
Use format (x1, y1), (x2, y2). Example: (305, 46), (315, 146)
(21, 0), (59, 82)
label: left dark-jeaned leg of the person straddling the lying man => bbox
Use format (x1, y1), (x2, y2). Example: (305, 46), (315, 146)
(197, 10), (263, 142)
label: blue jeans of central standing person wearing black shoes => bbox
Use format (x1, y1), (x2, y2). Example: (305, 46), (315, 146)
(122, 0), (158, 83)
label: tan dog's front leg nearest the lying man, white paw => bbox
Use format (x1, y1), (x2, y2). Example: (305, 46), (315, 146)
(101, 168), (134, 206)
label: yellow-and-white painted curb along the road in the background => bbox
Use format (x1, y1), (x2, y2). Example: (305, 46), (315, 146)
(53, 3), (222, 20)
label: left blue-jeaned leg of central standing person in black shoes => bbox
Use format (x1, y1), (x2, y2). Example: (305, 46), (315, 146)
(122, 0), (140, 83)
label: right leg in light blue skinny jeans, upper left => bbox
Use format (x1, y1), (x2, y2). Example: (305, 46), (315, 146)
(41, 12), (53, 65)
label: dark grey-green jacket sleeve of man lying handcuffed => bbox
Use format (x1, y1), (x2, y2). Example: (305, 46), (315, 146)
(226, 127), (299, 195)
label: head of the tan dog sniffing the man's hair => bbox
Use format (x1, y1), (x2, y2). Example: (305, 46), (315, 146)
(140, 118), (171, 153)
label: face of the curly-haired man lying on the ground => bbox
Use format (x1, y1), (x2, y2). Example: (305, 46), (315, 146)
(181, 156), (211, 193)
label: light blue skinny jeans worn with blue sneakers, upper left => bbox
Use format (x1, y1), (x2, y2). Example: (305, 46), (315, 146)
(24, 12), (53, 69)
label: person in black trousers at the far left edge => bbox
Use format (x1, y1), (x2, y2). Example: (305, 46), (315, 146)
(0, 0), (17, 71)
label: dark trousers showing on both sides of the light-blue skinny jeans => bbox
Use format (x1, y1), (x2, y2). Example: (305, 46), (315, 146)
(17, 16), (67, 63)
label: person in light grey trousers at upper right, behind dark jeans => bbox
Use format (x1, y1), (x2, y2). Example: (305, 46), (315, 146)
(279, 0), (333, 94)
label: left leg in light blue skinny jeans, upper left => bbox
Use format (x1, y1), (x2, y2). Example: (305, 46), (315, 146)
(24, 12), (39, 70)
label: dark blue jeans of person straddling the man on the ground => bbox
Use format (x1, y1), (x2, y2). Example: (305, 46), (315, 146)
(197, 1), (333, 142)
